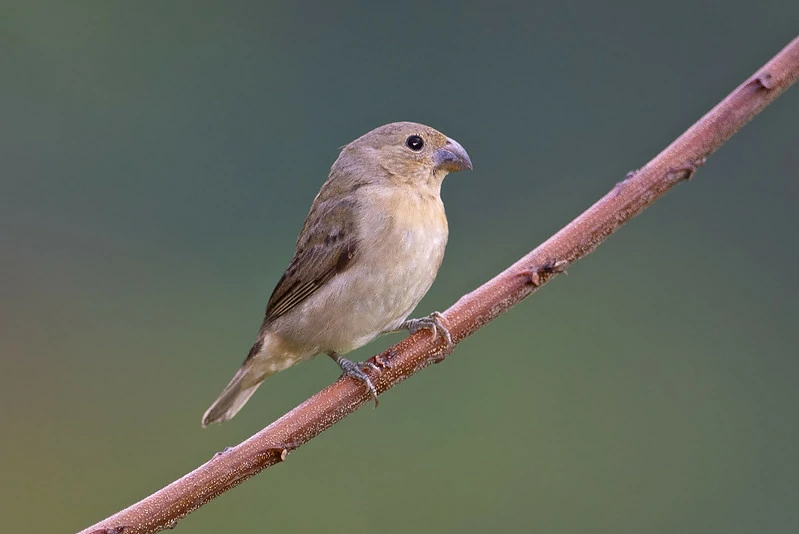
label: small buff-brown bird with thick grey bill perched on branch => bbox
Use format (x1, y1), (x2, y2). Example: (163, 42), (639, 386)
(202, 122), (472, 426)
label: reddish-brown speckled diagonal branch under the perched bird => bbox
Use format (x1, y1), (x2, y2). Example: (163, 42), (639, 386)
(76, 37), (799, 534)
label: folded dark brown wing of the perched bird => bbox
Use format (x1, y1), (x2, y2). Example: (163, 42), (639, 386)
(264, 202), (357, 325)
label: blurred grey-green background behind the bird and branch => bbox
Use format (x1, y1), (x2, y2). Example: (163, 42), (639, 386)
(0, 0), (799, 534)
